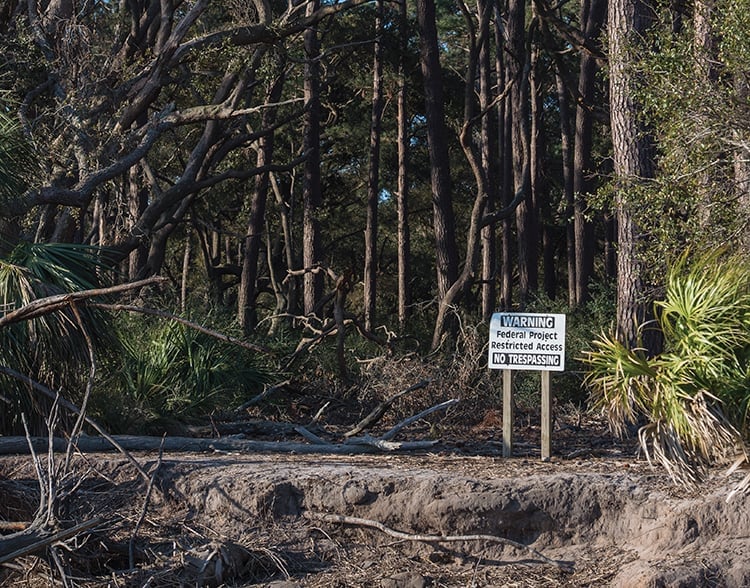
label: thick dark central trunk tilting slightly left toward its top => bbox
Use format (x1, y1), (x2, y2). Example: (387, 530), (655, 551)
(416, 0), (458, 302)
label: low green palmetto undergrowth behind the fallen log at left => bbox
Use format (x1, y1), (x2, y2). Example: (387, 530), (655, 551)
(94, 316), (269, 432)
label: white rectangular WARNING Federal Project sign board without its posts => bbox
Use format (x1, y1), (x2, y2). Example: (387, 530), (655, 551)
(489, 312), (565, 372)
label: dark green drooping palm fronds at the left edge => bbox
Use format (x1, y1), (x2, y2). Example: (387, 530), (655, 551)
(0, 243), (116, 434)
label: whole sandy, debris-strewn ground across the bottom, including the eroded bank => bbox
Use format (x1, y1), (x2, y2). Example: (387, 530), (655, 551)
(0, 390), (750, 588)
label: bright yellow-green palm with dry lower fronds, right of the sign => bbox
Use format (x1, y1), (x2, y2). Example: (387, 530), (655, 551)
(584, 251), (750, 483)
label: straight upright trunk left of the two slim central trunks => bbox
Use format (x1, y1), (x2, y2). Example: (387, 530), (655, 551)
(302, 0), (323, 314)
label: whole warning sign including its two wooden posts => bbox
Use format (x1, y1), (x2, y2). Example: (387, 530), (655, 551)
(488, 312), (565, 460)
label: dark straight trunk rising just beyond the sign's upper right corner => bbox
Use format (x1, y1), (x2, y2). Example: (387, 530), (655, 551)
(573, 0), (607, 304)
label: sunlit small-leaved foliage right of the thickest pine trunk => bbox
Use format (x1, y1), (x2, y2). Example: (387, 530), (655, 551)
(632, 0), (750, 262)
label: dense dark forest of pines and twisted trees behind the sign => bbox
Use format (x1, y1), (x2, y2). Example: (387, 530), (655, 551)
(0, 0), (750, 478)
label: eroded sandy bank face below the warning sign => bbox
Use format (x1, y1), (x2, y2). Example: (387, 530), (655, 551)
(164, 456), (750, 587)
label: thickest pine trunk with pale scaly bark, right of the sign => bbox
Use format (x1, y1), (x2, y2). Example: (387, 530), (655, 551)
(608, 0), (653, 346)
